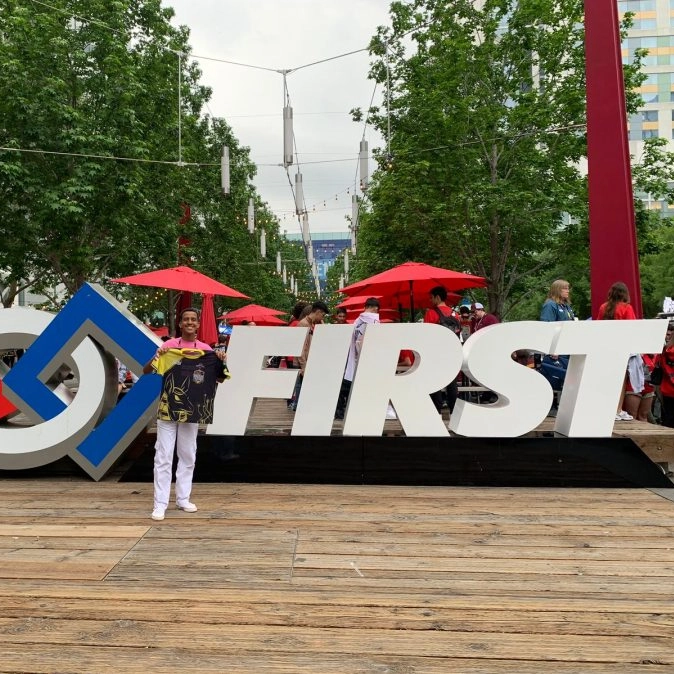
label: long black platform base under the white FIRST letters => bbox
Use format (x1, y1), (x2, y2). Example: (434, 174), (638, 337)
(121, 435), (674, 489)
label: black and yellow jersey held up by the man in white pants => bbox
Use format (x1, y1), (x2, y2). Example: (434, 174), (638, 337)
(152, 349), (223, 424)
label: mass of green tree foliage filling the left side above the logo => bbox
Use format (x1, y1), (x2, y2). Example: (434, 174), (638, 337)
(0, 0), (300, 304)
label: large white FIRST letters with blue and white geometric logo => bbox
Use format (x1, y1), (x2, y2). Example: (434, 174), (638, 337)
(0, 284), (667, 479)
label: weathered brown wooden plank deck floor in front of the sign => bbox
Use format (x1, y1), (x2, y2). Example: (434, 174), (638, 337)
(0, 476), (674, 674)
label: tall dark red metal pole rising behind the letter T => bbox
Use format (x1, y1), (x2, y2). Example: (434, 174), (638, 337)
(585, 0), (643, 318)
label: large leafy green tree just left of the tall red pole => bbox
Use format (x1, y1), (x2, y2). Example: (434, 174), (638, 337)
(357, 0), (638, 317)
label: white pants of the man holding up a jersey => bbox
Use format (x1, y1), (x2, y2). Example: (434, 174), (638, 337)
(154, 419), (199, 508)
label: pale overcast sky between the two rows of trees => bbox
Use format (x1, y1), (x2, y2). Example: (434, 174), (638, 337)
(164, 0), (390, 233)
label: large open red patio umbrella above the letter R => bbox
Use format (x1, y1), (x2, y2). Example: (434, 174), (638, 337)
(339, 262), (480, 317)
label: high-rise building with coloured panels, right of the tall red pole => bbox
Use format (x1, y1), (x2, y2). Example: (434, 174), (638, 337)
(618, 0), (674, 214)
